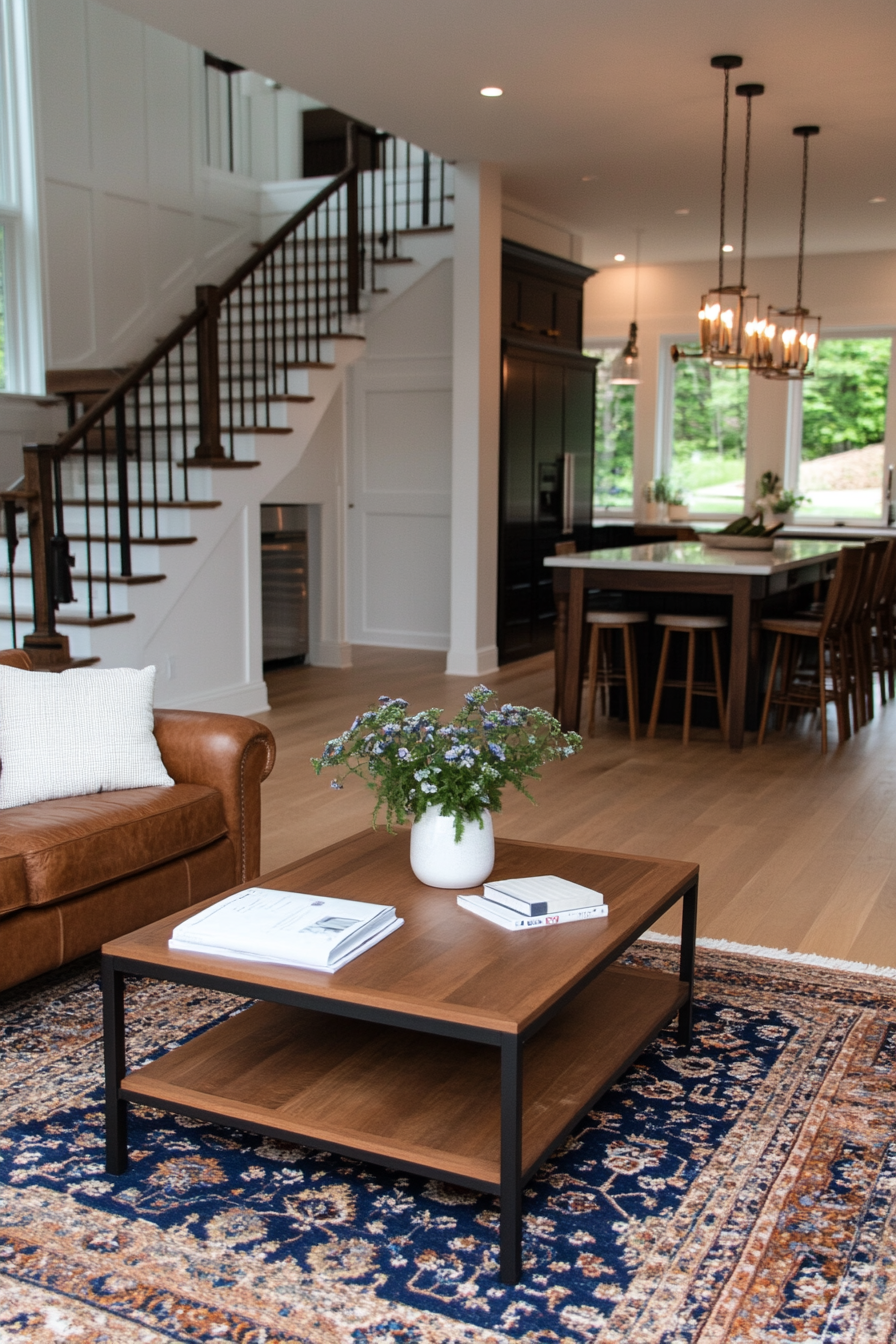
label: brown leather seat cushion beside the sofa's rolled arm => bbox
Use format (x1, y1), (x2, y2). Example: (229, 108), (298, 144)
(0, 784), (227, 909)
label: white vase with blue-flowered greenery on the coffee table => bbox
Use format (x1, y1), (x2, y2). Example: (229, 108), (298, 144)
(312, 685), (582, 888)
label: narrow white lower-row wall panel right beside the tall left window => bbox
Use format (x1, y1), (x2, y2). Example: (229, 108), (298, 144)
(44, 181), (97, 367)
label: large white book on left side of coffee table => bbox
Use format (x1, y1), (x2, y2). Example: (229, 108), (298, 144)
(168, 887), (404, 972)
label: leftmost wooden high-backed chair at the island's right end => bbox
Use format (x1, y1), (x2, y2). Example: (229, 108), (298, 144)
(756, 546), (864, 754)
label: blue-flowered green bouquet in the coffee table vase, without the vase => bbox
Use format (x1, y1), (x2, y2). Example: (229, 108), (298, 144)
(312, 685), (582, 841)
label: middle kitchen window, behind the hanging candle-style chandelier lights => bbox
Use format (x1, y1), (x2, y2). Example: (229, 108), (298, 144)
(658, 337), (750, 513)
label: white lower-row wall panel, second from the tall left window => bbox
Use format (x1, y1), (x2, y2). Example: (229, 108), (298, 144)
(97, 194), (149, 341)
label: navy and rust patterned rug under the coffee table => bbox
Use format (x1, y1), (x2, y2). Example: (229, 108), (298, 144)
(0, 942), (896, 1344)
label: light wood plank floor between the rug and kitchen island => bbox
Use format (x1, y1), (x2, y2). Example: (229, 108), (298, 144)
(251, 648), (896, 966)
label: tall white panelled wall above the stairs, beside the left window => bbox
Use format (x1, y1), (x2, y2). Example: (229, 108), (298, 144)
(34, 0), (268, 368)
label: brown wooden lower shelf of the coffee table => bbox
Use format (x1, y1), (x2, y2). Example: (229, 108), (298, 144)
(120, 966), (689, 1193)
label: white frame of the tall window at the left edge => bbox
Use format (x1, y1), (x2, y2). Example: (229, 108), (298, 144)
(0, 0), (46, 395)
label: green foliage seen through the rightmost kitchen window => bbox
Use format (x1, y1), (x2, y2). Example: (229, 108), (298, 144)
(802, 336), (891, 458)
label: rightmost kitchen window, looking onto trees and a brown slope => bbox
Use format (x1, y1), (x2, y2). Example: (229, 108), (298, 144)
(789, 336), (893, 519)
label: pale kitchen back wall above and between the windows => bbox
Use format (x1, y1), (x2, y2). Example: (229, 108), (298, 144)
(584, 250), (896, 513)
